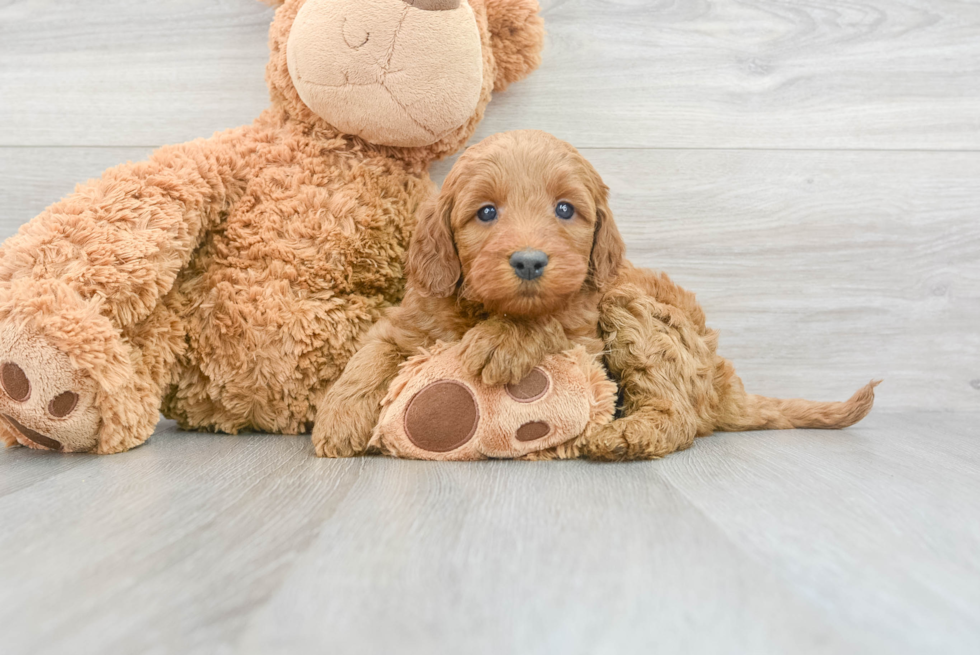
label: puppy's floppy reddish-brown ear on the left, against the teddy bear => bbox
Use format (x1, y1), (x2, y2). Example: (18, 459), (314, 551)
(406, 195), (462, 298)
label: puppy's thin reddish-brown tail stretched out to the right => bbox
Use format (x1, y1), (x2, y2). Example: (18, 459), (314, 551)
(715, 380), (881, 432)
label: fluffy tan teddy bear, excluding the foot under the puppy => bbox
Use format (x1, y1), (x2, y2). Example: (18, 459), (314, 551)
(0, 0), (543, 453)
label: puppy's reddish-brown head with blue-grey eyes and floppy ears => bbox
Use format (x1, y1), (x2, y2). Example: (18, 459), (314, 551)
(408, 131), (625, 316)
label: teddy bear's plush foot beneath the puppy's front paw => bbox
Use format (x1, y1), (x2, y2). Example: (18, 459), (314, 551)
(370, 343), (616, 460)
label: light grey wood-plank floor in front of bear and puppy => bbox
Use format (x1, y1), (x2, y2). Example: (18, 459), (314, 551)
(0, 412), (980, 655)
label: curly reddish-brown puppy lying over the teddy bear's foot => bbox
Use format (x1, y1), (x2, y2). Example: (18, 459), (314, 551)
(313, 131), (877, 460)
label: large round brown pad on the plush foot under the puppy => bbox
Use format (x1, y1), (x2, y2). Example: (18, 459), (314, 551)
(405, 380), (480, 453)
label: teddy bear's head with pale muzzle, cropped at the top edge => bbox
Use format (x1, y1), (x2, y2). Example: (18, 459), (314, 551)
(265, 0), (544, 157)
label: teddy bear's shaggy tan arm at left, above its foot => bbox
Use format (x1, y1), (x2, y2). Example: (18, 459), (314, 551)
(0, 139), (244, 327)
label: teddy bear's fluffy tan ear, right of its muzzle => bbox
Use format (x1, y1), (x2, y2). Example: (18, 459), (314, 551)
(484, 0), (544, 91)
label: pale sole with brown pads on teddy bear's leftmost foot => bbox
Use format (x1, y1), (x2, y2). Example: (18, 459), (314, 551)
(0, 329), (100, 452)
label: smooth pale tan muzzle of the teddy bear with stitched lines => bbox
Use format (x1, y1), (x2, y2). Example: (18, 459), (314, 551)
(286, 0), (485, 148)
